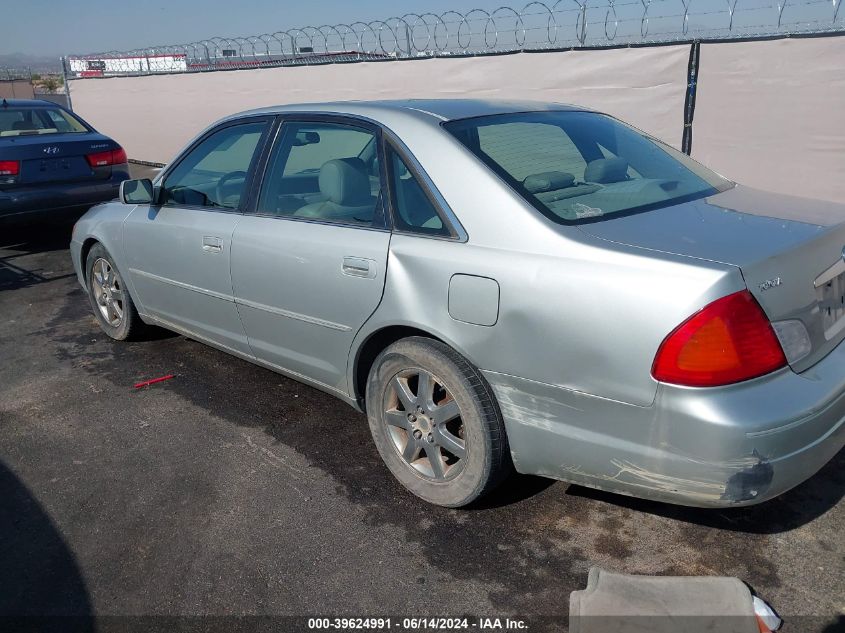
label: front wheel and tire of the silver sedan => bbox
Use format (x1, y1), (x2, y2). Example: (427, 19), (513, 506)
(85, 243), (144, 341)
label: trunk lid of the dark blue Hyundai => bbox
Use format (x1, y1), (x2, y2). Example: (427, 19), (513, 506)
(0, 132), (117, 187)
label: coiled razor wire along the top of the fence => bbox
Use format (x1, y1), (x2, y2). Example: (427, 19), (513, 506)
(62, 0), (845, 77)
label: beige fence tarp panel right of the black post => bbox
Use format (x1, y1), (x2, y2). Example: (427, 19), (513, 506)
(692, 37), (845, 202)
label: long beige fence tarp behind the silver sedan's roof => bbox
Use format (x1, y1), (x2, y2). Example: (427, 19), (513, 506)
(70, 45), (689, 162)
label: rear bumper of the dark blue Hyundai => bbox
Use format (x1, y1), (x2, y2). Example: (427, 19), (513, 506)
(0, 168), (129, 222)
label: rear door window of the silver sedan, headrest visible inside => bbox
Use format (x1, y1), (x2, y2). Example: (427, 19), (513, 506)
(257, 122), (381, 225)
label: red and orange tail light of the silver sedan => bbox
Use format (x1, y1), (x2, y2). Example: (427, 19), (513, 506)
(651, 290), (786, 387)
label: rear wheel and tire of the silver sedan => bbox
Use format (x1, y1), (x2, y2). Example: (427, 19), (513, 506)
(366, 337), (513, 508)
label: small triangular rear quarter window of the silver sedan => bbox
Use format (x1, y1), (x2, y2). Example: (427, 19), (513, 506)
(387, 146), (450, 235)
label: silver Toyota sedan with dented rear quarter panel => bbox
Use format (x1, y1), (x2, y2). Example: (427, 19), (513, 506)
(71, 100), (845, 507)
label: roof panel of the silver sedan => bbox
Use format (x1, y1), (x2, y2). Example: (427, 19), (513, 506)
(227, 99), (584, 121)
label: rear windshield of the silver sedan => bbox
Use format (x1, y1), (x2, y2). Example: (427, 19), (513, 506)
(444, 112), (733, 224)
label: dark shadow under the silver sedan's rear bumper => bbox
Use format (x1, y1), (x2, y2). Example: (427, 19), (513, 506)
(567, 449), (845, 534)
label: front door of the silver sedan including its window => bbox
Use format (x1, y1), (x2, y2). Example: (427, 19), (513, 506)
(124, 118), (272, 355)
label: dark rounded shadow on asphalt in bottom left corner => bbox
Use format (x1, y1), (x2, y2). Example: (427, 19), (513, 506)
(0, 456), (95, 632)
